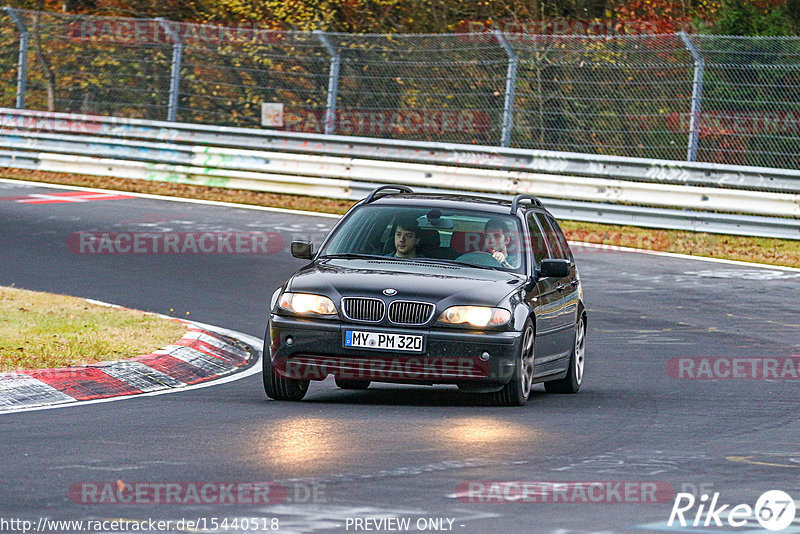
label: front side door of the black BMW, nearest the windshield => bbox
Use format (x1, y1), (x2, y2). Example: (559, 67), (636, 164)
(526, 212), (562, 376)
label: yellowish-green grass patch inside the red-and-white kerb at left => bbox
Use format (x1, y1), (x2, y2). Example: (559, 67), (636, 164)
(0, 287), (186, 371)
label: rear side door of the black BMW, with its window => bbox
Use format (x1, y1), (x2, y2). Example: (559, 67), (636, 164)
(537, 213), (579, 368)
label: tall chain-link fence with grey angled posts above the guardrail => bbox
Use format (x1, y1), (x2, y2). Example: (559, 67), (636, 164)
(0, 9), (800, 168)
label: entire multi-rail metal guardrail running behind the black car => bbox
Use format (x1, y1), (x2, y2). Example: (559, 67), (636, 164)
(0, 109), (800, 239)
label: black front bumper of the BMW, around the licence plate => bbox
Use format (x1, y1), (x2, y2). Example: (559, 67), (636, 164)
(264, 314), (521, 388)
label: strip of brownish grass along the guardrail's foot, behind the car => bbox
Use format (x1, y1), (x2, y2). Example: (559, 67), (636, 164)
(0, 168), (800, 267)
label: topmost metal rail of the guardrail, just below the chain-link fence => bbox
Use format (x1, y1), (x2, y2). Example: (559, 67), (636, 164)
(6, 108), (800, 192)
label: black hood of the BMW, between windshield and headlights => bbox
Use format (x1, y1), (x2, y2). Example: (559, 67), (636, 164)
(287, 258), (525, 309)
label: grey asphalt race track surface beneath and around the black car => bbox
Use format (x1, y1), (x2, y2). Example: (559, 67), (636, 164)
(0, 183), (800, 534)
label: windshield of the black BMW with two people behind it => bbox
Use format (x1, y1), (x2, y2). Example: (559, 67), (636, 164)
(320, 205), (526, 273)
